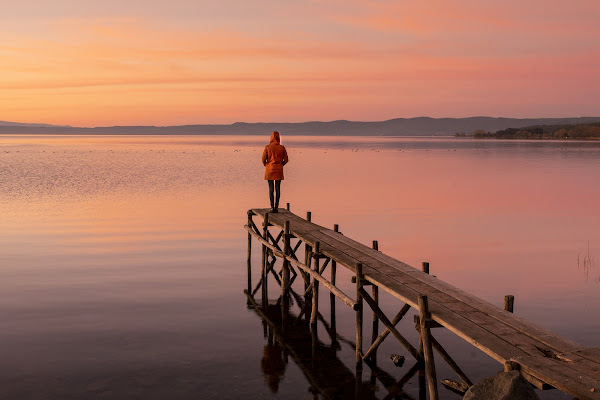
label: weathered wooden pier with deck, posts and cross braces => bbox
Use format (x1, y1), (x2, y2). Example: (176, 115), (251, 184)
(245, 208), (600, 400)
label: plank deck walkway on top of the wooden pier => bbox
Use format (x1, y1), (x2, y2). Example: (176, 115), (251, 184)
(251, 209), (600, 400)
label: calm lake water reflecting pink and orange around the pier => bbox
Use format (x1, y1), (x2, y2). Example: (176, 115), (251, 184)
(0, 136), (600, 399)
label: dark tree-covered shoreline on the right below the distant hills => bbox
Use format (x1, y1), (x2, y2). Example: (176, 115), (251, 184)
(455, 122), (600, 140)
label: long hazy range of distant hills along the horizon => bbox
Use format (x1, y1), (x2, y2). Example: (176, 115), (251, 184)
(0, 117), (600, 136)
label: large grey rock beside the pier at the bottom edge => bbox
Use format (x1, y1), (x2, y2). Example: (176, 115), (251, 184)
(463, 371), (540, 400)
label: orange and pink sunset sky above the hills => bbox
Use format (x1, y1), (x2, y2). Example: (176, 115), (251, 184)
(0, 0), (600, 126)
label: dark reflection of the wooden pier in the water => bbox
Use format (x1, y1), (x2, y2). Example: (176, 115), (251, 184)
(247, 293), (425, 400)
